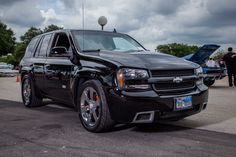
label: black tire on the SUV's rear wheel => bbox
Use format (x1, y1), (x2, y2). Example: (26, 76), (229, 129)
(21, 75), (43, 108)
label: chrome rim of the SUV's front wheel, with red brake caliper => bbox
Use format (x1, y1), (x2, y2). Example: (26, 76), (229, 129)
(80, 87), (101, 127)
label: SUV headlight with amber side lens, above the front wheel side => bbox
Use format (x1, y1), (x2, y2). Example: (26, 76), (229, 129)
(116, 68), (150, 90)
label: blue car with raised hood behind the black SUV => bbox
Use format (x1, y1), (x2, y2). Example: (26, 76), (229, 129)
(183, 44), (226, 86)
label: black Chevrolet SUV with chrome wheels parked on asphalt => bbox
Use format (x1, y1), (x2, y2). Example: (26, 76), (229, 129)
(20, 30), (208, 132)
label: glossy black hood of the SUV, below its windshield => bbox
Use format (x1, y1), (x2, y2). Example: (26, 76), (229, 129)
(89, 51), (199, 69)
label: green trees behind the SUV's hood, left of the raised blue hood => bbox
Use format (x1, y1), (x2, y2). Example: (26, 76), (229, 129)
(156, 43), (199, 57)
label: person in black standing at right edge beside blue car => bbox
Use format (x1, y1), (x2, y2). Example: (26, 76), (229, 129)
(223, 47), (236, 87)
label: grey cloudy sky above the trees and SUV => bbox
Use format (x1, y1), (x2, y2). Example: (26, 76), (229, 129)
(0, 0), (236, 50)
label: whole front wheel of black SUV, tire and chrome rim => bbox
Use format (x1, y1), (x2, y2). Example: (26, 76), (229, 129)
(78, 80), (114, 132)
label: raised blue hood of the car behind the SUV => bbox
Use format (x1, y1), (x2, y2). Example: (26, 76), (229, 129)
(187, 45), (220, 65)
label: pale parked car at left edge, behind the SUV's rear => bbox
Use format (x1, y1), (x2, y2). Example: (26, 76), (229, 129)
(0, 63), (19, 77)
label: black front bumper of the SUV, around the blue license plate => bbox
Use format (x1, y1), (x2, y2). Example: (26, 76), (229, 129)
(105, 85), (208, 123)
